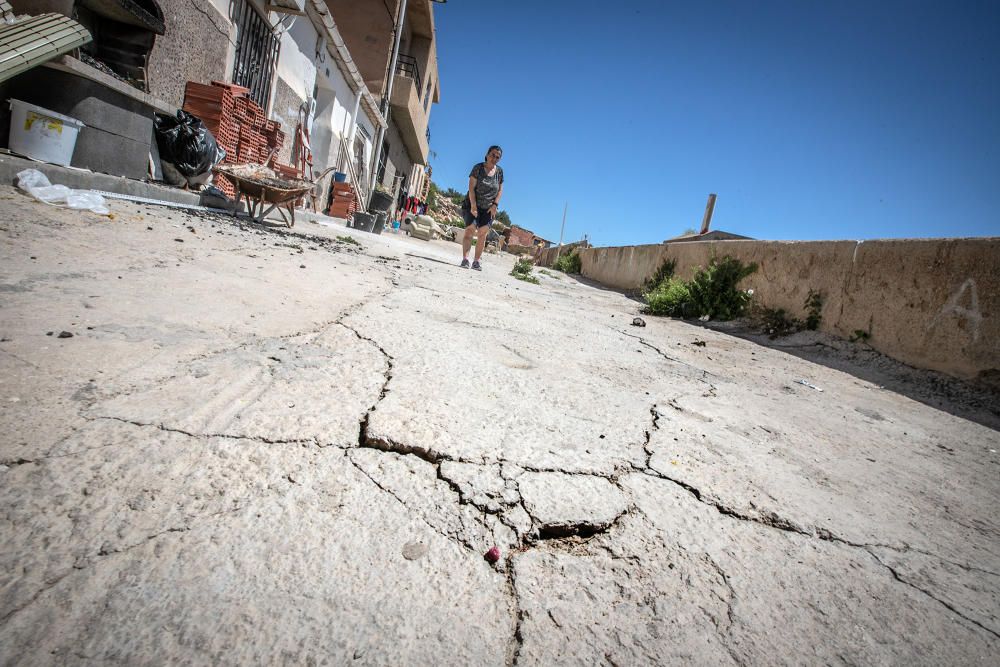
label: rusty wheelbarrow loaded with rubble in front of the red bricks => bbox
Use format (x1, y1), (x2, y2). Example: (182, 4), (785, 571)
(212, 164), (334, 227)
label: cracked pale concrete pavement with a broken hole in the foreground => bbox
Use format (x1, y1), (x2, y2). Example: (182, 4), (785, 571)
(0, 188), (1000, 665)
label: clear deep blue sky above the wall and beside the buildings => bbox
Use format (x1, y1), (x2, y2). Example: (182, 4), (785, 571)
(431, 0), (1000, 245)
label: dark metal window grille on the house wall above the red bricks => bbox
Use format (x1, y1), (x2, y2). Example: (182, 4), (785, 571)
(232, 0), (281, 109)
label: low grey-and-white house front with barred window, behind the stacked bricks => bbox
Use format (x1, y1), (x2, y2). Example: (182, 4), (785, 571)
(150, 0), (385, 209)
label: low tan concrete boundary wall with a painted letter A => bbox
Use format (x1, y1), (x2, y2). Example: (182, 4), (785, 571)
(545, 238), (1000, 384)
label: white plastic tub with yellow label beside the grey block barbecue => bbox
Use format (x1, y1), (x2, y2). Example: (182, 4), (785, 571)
(10, 98), (84, 167)
